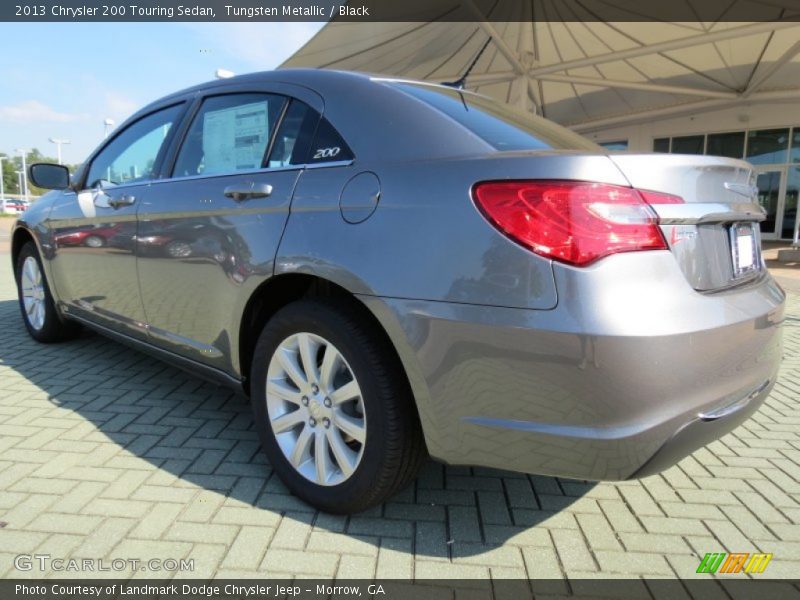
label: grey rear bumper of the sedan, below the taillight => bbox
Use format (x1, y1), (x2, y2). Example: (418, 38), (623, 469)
(365, 253), (785, 480)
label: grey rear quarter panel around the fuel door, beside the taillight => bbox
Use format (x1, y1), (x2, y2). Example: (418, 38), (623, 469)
(276, 153), (626, 310)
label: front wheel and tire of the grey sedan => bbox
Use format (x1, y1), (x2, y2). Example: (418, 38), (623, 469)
(15, 241), (80, 343)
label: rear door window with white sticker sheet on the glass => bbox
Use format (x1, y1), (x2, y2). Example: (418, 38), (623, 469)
(173, 94), (287, 177)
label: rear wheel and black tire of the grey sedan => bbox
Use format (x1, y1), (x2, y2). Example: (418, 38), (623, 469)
(250, 300), (426, 514)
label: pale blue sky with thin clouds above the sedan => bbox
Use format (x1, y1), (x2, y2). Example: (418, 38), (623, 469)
(0, 23), (324, 163)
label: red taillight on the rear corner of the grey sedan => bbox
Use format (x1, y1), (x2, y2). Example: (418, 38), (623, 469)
(473, 181), (683, 266)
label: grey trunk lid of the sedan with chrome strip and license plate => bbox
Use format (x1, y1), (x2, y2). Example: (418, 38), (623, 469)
(609, 154), (765, 292)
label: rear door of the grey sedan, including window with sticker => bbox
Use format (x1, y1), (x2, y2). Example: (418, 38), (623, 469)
(137, 84), (321, 373)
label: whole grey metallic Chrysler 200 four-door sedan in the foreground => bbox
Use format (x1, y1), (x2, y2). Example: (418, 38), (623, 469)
(12, 70), (784, 512)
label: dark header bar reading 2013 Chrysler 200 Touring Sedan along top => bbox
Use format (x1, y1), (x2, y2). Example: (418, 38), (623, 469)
(0, 0), (800, 26)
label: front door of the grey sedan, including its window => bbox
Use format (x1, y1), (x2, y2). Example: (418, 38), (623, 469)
(48, 103), (185, 339)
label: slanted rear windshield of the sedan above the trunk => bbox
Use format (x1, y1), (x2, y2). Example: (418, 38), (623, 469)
(394, 83), (603, 152)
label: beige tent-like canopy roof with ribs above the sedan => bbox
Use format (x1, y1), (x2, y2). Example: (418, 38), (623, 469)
(282, 15), (800, 131)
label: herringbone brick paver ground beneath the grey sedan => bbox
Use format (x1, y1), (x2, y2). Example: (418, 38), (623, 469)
(0, 253), (800, 588)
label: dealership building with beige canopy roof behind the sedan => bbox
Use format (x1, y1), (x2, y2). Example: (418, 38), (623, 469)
(283, 20), (800, 239)
